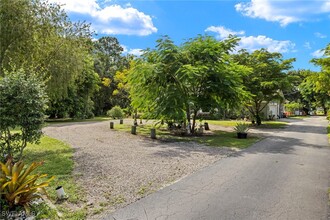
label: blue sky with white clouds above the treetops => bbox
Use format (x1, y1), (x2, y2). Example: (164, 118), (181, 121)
(50, 0), (330, 70)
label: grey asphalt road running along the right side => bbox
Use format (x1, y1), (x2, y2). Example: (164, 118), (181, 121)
(106, 117), (330, 220)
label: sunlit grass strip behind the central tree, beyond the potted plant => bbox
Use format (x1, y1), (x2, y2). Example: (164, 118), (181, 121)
(206, 120), (288, 129)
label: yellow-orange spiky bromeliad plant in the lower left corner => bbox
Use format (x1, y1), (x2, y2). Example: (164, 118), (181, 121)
(0, 160), (54, 213)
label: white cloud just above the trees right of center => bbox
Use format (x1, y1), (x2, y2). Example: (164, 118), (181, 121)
(205, 26), (295, 53)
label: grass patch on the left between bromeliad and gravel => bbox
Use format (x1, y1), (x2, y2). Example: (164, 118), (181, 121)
(24, 136), (87, 219)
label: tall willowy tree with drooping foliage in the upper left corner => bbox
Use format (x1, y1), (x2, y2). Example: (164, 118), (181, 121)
(0, 0), (92, 99)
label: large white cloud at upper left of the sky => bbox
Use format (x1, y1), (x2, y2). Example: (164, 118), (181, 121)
(52, 0), (157, 36)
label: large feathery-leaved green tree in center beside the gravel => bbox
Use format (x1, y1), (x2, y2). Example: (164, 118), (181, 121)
(129, 36), (247, 133)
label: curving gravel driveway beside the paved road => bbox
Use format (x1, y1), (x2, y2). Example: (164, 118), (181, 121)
(44, 122), (234, 219)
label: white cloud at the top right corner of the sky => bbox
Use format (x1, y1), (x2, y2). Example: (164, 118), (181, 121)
(235, 0), (330, 26)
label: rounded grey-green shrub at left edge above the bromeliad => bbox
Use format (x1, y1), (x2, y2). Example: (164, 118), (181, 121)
(0, 69), (46, 161)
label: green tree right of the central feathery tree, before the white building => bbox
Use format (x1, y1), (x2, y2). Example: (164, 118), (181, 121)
(233, 49), (295, 125)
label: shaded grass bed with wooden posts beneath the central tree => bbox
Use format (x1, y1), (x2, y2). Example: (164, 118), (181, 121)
(114, 124), (260, 149)
